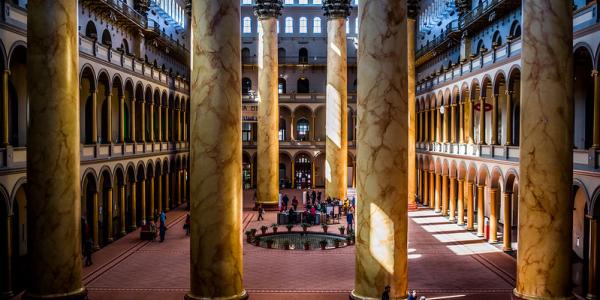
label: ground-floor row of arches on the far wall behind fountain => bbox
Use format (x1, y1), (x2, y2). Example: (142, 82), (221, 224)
(242, 151), (356, 189)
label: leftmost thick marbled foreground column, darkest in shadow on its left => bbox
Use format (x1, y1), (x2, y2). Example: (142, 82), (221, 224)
(23, 0), (87, 299)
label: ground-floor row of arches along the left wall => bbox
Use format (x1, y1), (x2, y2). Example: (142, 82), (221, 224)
(0, 155), (189, 293)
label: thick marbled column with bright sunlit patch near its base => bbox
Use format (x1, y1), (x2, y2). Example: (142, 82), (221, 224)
(352, 0), (409, 299)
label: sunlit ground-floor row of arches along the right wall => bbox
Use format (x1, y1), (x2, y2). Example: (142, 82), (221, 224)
(416, 155), (600, 296)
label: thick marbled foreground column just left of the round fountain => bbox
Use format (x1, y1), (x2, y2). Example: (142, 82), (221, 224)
(185, 0), (245, 300)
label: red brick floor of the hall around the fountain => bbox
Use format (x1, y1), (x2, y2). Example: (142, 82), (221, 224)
(19, 191), (515, 300)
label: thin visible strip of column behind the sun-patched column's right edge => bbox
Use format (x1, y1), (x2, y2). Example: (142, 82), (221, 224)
(406, 15), (418, 209)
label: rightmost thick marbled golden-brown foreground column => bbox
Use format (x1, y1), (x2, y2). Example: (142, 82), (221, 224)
(514, 0), (573, 299)
